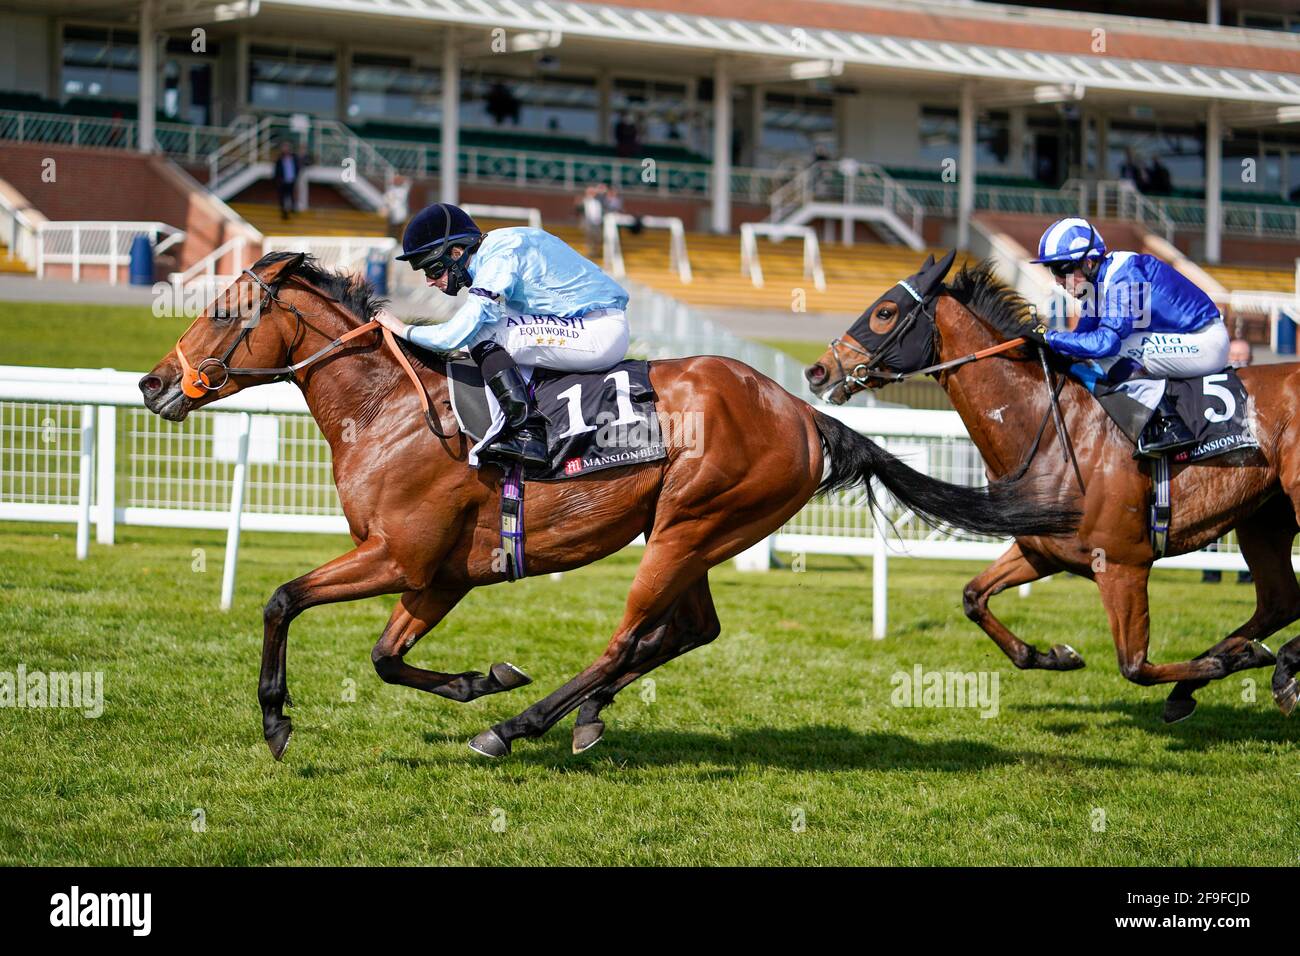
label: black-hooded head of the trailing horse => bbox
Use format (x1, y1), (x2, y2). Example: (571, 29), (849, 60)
(803, 250), (957, 405)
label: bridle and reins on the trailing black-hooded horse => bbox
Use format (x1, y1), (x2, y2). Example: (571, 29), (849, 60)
(831, 290), (1087, 493)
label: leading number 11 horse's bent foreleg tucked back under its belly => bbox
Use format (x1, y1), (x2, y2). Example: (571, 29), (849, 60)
(371, 588), (532, 702)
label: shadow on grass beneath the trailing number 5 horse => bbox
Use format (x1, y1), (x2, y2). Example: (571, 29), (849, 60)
(1019, 691), (1300, 750)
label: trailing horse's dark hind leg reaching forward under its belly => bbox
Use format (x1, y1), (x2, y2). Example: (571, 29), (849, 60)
(1165, 494), (1300, 723)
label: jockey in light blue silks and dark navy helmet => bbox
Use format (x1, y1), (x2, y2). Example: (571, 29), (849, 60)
(377, 203), (628, 468)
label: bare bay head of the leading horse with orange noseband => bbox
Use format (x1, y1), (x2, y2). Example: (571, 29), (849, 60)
(139, 252), (306, 421)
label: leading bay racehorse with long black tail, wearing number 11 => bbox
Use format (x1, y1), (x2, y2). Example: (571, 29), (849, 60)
(139, 252), (1078, 760)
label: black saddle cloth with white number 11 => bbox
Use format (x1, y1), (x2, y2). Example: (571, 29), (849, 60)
(447, 359), (667, 481)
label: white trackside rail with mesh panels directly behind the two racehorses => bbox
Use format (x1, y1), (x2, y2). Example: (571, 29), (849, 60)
(0, 365), (1279, 624)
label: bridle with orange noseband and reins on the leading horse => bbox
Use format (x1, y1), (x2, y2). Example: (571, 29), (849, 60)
(176, 268), (455, 438)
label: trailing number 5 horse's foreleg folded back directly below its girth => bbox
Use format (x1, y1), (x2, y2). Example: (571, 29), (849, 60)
(1097, 562), (1271, 719)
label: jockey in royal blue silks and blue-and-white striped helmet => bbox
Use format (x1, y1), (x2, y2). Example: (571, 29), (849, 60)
(1032, 219), (1229, 451)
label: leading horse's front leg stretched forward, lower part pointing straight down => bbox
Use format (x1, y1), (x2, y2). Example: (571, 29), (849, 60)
(257, 538), (404, 760)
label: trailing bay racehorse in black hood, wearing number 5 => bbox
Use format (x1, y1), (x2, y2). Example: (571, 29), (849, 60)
(805, 254), (1300, 722)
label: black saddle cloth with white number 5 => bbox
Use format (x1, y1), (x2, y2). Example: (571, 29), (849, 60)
(1084, 368), (1260, 463)
